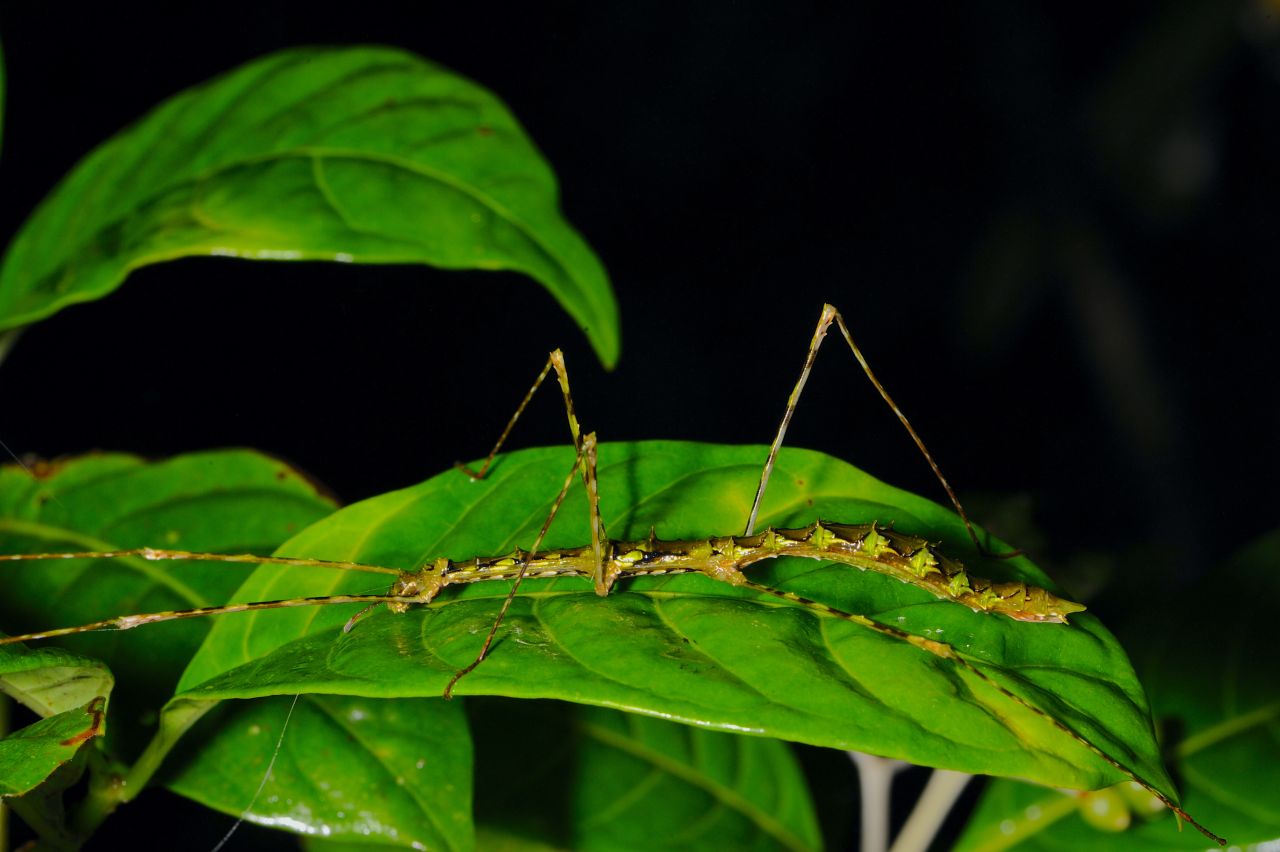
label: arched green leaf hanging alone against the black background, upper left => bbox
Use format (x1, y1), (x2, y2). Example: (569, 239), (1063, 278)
(0, 47), (618, 366)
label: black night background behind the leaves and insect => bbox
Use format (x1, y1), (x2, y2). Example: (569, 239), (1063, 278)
(0, 0), (1280, 844)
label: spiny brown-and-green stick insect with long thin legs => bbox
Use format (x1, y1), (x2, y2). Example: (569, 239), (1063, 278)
(0, 306), (1219, 840)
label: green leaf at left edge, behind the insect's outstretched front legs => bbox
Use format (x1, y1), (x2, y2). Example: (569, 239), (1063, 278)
(0, 450), (333, 751)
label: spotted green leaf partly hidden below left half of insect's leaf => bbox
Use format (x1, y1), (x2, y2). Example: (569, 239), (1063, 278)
(165, 695), (475, 849)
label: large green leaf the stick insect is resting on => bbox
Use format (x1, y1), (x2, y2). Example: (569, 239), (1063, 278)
(169, 441), (1174, 797)
